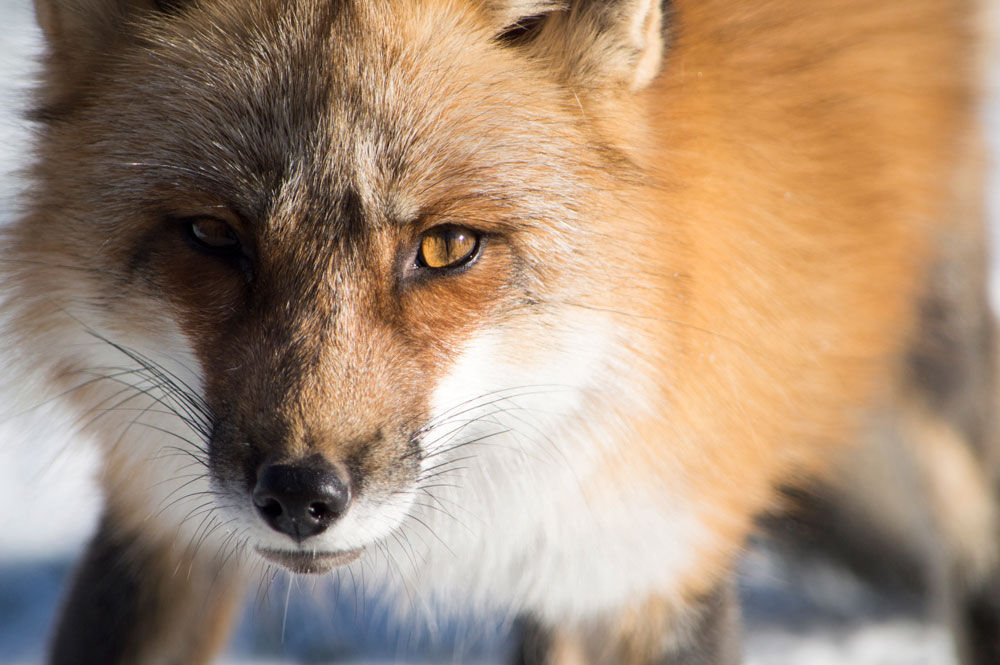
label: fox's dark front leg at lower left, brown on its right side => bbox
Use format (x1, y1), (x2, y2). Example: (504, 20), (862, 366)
(49, 514), (242, 665)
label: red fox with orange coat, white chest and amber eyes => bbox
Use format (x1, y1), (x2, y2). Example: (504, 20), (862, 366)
(0, 0), (1000, 665)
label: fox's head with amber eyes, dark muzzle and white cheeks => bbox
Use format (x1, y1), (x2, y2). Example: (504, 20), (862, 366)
(9, 0), (663, 571)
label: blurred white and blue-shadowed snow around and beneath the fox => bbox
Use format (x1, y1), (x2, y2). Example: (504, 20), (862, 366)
(0, 0), (1000, 665)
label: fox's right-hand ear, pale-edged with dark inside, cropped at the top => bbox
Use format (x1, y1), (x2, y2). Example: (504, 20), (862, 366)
(492, 0), (665, 91)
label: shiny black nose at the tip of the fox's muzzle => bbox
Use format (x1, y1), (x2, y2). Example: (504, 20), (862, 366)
(253, 457), (351, 542)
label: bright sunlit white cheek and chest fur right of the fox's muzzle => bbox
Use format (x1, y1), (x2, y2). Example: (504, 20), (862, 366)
(370, 317), (708, 621)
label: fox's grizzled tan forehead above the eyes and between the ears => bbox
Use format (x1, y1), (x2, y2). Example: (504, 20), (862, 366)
(74, 0), (608, 237)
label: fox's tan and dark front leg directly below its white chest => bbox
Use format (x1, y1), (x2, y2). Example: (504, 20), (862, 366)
(513, 583), (742, 665)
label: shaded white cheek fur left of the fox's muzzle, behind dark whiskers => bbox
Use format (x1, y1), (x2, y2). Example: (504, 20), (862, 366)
(67, 320), (237, 553)
